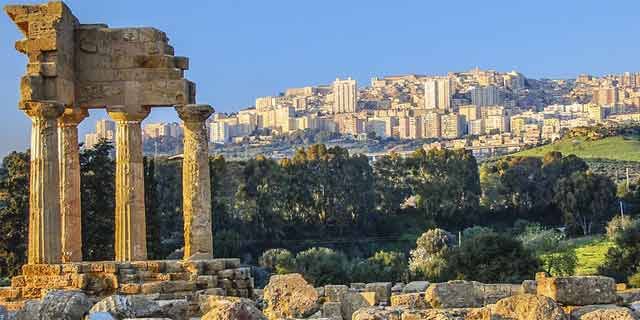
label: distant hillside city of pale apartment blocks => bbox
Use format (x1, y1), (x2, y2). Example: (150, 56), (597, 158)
(85, 68), (640, 156)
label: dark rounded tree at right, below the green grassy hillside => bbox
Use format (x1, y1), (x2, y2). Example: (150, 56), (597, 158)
(554, 171), (616, 235)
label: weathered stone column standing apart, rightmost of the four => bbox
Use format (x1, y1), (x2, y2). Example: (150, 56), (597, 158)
(176, 104), (213, 260)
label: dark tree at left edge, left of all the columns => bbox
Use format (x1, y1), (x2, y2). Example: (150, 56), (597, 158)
(0, 151), (30, 278)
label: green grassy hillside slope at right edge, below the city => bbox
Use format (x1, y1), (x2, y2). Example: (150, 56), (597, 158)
(514, 136), (640, 161)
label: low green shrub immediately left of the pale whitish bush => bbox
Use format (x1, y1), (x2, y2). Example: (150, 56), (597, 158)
(351, 251), (407, 282)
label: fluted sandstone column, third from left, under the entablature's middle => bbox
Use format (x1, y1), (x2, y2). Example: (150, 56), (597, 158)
(107, 106), (149, 261)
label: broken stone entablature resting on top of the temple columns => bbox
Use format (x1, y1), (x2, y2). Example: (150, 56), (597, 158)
(5, 1), (195, 108)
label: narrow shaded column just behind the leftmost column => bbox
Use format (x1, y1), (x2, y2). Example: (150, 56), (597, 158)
(58, 108), (89, 262)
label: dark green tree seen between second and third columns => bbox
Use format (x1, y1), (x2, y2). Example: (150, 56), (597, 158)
(80, 140), (115, 261)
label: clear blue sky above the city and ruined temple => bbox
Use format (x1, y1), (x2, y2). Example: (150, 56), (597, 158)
(0, 0), (640, 155)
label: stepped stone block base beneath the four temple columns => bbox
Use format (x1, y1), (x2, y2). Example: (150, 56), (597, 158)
(0, 259), (253, 312)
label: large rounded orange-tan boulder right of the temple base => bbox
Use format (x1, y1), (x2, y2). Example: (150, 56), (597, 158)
(264, 273), (319, 319)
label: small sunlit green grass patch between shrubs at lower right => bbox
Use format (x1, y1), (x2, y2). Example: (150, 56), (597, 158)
(567, 236), (613, 276)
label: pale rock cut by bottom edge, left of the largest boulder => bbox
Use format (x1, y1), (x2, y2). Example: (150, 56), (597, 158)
(202, 297), (267, 320)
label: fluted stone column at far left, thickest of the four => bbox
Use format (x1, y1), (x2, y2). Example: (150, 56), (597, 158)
(23, 101), (64, 264)
